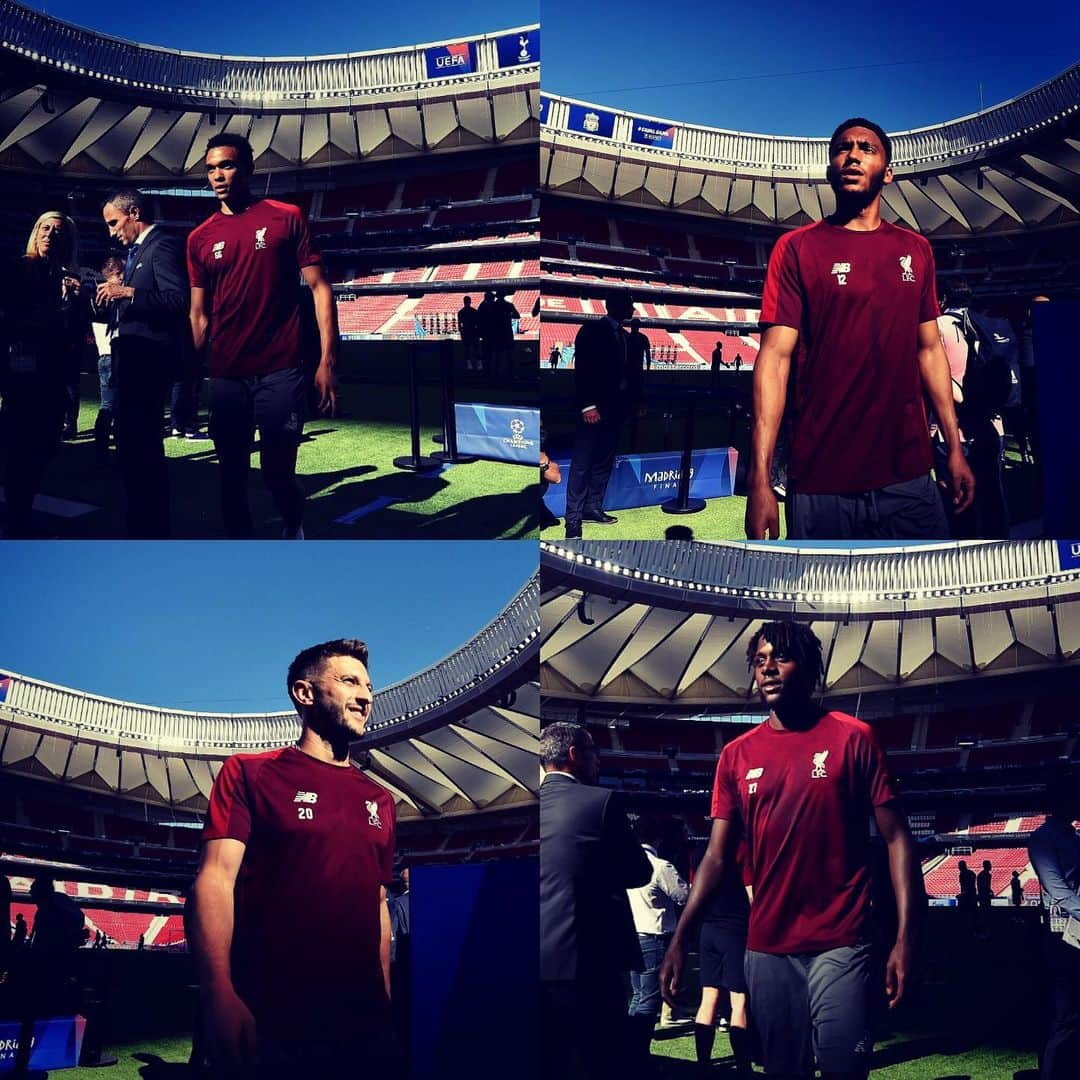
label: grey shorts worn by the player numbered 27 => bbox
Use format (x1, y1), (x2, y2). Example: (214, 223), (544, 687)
(746, 945), (874, 1076)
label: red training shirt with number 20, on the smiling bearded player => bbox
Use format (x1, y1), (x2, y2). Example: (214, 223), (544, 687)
(202, 746), (395, 1031)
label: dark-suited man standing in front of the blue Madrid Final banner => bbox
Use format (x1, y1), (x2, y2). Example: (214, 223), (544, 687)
(566, 292), (642, 540)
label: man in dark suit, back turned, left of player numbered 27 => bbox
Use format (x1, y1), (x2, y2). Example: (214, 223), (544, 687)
(540, 724), (652, 1080)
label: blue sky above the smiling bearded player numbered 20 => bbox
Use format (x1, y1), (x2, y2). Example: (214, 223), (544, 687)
(0, 541), (538, 713)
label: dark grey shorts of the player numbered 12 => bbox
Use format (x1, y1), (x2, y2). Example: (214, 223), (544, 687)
(787, 474), (949, 540)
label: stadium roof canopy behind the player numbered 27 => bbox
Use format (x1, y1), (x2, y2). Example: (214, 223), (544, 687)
(540, 540), (1080, 706)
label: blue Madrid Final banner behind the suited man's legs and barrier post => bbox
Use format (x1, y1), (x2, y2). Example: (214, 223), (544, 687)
(543, 446), (739, 517)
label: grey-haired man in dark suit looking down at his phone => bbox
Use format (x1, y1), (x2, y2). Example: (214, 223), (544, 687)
(97, 191), (191, 539)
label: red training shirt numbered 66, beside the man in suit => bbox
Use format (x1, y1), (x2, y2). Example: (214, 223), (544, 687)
(188, 199), (322, 378)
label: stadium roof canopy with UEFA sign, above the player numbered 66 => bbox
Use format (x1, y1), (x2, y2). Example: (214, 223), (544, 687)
(0, 0), (540, 180)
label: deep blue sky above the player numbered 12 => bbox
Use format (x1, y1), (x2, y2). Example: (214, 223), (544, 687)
(541, 0), (1080, 135)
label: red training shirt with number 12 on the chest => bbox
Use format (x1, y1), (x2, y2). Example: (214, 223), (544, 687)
(761, 221), (940, 495)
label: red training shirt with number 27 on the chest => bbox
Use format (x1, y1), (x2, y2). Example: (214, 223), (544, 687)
(712, 713), (896, 954)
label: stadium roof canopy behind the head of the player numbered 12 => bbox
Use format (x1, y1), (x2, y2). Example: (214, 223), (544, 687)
(540, 64), (1080, 238)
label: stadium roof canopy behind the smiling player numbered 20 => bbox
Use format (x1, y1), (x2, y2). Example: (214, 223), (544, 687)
(0, 576), (540, 818)
